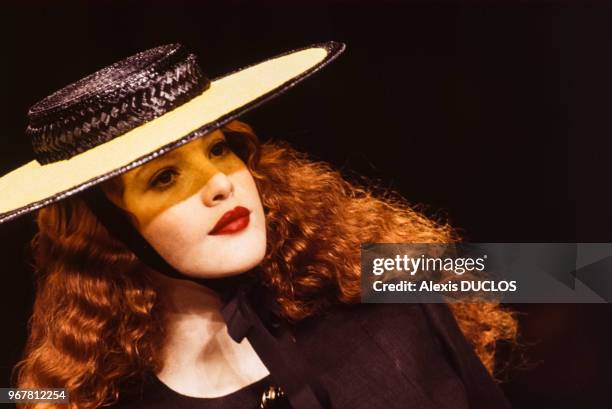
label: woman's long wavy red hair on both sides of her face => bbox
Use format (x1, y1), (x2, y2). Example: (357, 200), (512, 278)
(13, 121), (517, 409)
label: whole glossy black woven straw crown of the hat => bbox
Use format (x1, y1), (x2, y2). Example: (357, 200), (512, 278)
(26, 44), (210, 164)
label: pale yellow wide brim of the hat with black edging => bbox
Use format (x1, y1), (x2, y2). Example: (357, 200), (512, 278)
(0, 42), (344, 223)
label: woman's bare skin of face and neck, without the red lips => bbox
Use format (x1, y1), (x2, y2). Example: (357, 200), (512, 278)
(105, 130), (269, 397)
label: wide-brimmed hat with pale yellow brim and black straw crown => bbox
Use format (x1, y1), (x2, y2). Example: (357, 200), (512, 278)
(0, 42), (344, 223)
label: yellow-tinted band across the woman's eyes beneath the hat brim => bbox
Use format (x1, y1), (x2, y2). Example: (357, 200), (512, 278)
(109, 130), (246, 229)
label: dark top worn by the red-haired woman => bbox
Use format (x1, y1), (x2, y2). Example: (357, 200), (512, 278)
(109, 304), (510, 409)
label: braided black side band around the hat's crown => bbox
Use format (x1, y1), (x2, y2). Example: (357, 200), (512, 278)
(26, 54), (210, 165)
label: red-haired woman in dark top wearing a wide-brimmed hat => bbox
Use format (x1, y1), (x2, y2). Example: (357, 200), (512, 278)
(0, 43), (516, 409)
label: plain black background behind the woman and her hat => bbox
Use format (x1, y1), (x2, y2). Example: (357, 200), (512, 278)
(0, 0), (612, 408)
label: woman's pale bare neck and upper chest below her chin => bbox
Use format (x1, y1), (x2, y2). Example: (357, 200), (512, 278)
(150, 271), (268, 396)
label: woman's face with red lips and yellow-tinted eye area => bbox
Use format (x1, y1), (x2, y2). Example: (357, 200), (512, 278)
(104, 130), (266, 277)
